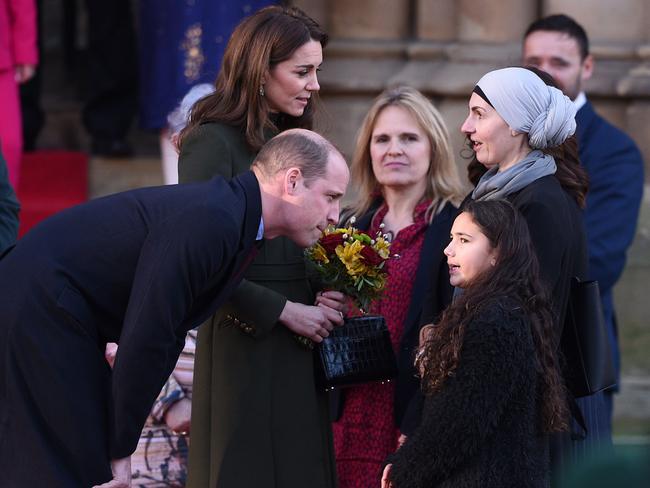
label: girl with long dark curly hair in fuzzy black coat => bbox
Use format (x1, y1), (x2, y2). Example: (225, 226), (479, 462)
(382, 200), (568, 488)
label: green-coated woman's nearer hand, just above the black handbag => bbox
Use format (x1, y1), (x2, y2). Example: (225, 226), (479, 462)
(278, 300), (343, 342)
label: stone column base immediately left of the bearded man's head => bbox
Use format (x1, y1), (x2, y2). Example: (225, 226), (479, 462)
(457, 0), (537, 43)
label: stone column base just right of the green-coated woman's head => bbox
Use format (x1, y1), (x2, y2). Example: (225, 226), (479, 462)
(328, 0), (411, 40)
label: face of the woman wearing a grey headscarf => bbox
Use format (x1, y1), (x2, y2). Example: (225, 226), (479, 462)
(460, 93), (530, 171)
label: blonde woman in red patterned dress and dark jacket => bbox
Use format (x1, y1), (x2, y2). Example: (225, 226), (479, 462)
(334, 86), (463, 488)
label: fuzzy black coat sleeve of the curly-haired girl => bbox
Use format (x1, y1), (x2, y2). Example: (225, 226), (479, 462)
(388, 306), (530, 488)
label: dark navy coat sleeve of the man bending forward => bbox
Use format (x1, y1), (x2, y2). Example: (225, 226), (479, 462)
(110, 206), (240, 459)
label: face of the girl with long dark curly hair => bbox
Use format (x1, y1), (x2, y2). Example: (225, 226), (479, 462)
(444, 212), (497, 288)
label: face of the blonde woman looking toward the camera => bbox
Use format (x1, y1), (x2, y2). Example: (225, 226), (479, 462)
(370, 105), (431, 193)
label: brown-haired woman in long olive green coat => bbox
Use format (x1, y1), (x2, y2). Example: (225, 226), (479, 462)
(179, 6), (344, 488)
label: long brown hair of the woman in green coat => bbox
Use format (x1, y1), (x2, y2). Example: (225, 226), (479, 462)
(179, 6), (328, 151)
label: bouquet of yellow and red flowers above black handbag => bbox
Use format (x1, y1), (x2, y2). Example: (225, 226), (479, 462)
(305, 217), (390, 312)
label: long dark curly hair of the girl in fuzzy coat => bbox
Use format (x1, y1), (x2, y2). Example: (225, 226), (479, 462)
(416, 200), (568, 432)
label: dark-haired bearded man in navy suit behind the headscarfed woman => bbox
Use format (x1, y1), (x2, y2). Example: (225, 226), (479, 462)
(523, 15), (643, 446)
